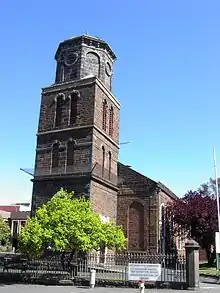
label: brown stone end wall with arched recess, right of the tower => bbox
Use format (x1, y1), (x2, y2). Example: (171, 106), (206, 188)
(117, 163), (157, 250)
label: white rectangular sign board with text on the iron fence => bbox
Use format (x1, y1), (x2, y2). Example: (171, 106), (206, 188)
(128, 263), (161, 281)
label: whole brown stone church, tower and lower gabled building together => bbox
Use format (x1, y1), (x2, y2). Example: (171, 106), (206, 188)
(32, 35), (177, 252)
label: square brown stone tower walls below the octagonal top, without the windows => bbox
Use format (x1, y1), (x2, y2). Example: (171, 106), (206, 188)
(33, 78), (119, 220)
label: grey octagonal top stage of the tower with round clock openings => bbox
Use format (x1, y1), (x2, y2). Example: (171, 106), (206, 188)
(55, 36), (116, 90)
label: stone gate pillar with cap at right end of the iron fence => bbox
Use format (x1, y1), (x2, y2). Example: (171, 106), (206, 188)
(185, 239), (199, 289)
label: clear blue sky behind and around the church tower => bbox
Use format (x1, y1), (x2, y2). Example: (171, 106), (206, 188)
(0, 0), (220, 203)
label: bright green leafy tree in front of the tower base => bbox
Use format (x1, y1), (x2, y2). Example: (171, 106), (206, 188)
(19, 189), (126, 255)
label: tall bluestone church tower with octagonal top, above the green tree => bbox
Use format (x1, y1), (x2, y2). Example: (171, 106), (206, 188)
(32, 35), (120, 220)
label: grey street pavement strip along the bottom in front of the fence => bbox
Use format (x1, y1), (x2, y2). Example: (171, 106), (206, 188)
(0, 283), (220, 293)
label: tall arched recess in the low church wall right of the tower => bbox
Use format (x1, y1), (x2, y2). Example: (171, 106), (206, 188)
(128, 202), (144, 250)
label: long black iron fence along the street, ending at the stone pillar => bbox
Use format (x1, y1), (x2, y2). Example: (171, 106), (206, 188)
(0, 253), (186, 286)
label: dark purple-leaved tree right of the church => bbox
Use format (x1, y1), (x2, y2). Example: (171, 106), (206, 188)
(172, 180), (218, 250)
